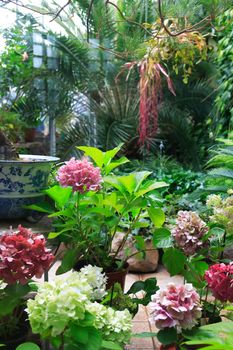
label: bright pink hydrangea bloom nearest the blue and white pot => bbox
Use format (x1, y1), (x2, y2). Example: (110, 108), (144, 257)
(57, 158), (102, 193)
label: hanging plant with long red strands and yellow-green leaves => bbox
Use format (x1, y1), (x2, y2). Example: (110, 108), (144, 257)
(121, 19), (207, 146)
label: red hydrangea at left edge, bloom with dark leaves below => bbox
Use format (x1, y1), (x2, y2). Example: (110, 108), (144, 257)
(0, 226), (54, 350)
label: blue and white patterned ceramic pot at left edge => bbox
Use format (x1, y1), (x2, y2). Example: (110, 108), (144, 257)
(0, 155), (59, 219)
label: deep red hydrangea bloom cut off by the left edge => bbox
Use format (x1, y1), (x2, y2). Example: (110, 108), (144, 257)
(0, 225), (54, 284)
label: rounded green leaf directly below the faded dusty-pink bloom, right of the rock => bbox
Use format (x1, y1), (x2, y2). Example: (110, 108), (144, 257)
(163, 248), (186, 276)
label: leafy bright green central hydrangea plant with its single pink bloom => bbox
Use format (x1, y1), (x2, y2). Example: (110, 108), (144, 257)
(30, 145), (166, 284)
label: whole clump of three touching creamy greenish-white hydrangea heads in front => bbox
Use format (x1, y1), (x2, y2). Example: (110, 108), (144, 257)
(26, 265), (132, 344)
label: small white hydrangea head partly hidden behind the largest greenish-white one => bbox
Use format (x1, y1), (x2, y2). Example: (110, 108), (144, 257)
(80, 265), (107, 300)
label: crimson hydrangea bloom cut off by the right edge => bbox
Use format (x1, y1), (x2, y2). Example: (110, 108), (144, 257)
(205, 263), (233, 303)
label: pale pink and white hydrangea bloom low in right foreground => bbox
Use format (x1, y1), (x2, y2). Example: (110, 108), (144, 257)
(151, 283), (202, 331)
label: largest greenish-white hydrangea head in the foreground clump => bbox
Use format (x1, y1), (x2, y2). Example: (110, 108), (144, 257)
(27, 272), (92, 337)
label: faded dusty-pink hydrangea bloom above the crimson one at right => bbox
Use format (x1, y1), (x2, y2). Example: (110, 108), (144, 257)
(172, 210), (208, 256)
